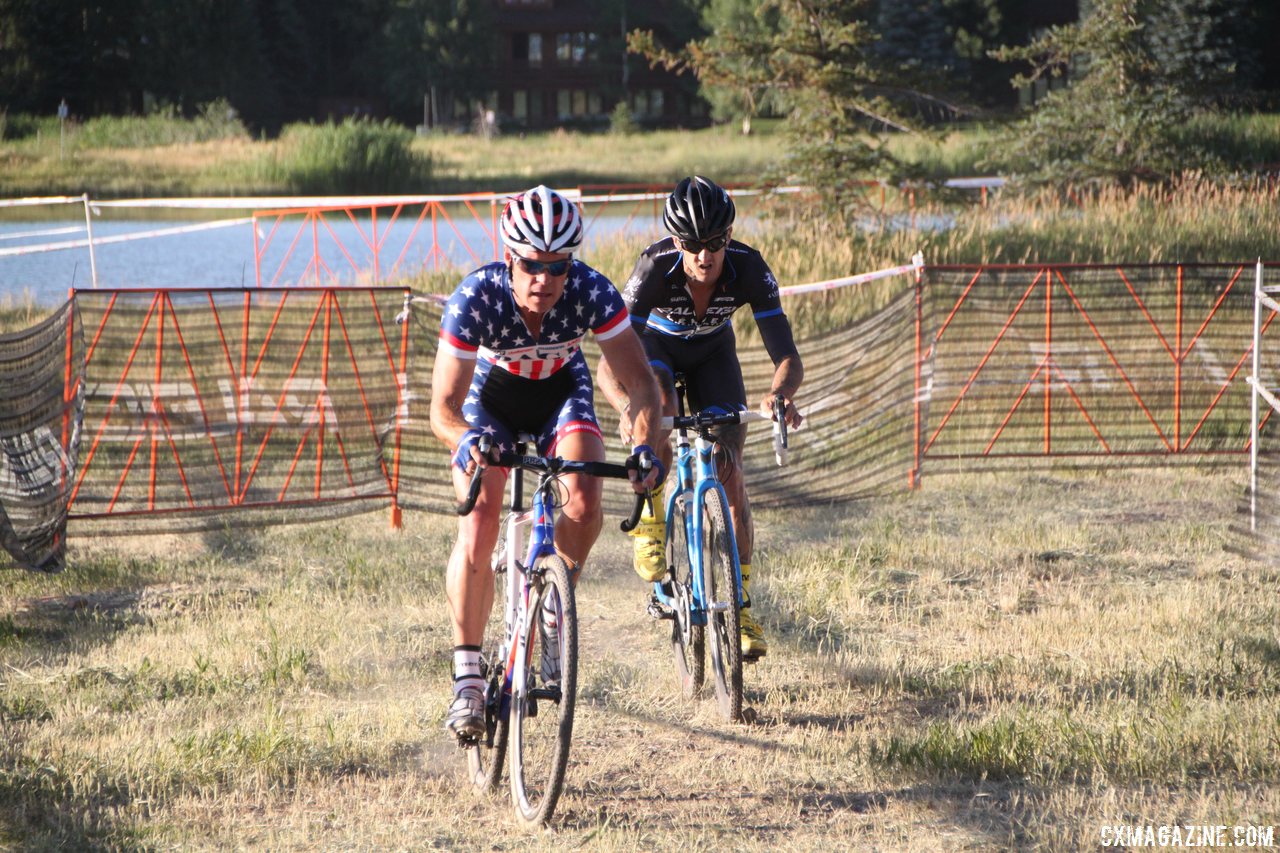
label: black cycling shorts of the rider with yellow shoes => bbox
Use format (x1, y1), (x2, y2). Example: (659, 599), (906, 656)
(640, 324), (746, 414)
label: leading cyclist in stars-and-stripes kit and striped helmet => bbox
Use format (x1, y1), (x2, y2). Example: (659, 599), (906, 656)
(431, 186), (664, 738)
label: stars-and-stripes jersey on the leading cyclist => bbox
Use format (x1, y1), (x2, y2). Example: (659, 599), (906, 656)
(440, 260), (627, 379)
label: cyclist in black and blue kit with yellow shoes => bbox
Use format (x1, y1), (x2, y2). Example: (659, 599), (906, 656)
(598, 175), (804, 660)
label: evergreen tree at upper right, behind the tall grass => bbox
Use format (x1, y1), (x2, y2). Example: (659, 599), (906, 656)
(997, 0), (1213, 183)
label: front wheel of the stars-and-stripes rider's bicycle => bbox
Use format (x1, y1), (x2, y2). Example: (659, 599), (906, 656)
(508, 556), (577, 827)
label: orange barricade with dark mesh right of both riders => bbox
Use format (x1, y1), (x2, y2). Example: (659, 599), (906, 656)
(910, 264), (1275, 473)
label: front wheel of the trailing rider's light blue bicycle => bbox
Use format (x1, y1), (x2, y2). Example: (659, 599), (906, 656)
(701, 489), (742, 722)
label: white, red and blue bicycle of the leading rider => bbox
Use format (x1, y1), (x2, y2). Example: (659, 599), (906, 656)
(457, 435), (645, 827)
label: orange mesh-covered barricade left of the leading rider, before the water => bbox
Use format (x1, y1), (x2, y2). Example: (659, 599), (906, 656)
(69, 287), (408, 519)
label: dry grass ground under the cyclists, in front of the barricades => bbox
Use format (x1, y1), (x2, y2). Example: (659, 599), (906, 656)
(0, 461), (1280, 850)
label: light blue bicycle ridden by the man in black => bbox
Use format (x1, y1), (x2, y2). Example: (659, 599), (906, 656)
(649, 374), (787, 722)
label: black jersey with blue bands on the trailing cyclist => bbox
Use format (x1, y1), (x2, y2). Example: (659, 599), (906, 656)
(622, 237), (796, 364)
